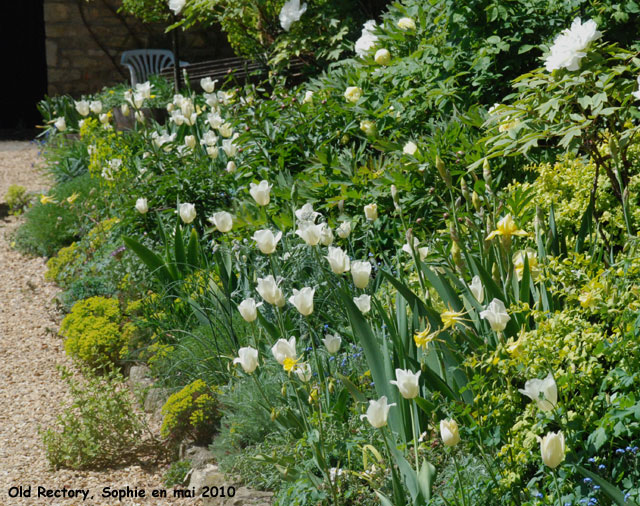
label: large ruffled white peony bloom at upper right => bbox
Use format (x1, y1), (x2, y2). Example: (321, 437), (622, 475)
(545, 18), (602, 72)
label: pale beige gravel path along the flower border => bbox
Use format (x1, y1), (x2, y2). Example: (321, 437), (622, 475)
(0, 142), (201, 506)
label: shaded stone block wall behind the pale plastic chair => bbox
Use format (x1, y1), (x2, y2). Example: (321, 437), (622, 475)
(44, 0), (231, 97)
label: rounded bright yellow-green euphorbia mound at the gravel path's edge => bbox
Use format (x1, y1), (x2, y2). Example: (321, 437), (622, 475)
(60, 297), (129, 367)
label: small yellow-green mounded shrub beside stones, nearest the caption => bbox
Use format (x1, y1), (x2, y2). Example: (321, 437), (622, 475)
(160, 380), (220, 444)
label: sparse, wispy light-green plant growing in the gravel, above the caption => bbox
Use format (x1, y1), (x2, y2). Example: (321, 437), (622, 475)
(41, 369), (155, 470)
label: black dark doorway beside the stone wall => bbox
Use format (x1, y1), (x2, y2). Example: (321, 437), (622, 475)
(0, 0), (47, 139)
